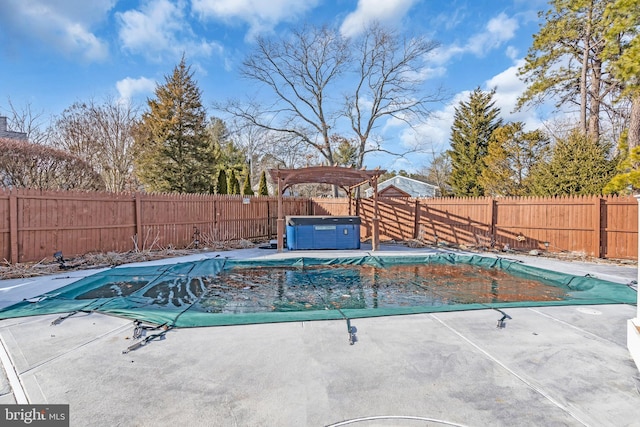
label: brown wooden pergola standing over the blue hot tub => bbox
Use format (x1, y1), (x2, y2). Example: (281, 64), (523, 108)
(269, 166), (386, 252)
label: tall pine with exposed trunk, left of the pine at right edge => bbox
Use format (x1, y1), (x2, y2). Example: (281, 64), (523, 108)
(518, 0), (616, 139)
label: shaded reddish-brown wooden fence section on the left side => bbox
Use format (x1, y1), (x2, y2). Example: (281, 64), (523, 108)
(0, 190), (311, 263)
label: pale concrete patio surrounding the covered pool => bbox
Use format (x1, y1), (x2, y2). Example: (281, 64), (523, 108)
(0, 245), (640, 427)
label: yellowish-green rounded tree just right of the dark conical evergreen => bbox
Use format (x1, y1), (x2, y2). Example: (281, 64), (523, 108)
(479, 122), (549, 196)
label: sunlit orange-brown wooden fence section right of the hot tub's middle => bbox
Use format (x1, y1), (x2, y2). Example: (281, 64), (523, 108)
(313, 196), (638, 259)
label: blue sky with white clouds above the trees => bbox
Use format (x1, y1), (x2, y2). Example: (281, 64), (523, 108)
(0, 0), (548, 171)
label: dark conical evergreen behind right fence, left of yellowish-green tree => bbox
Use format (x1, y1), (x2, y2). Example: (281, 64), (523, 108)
(447, 88), (502, 197)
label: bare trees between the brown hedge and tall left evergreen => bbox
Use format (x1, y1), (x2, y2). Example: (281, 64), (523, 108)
(51, 98), (137, 191)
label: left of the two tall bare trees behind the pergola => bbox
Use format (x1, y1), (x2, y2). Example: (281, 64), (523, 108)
(223, 27), (350, 169)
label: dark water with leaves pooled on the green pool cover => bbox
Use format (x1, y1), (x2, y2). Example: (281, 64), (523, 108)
(78, 264), (566, 313)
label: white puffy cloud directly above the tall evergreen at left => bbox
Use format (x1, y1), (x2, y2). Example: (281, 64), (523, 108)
(116, 0), (223, 60)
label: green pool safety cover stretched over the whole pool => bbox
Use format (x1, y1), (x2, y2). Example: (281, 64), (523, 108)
(0, 254), (637, 327)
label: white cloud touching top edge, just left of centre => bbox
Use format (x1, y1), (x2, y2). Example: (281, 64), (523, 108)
(191, 0), (319, 39)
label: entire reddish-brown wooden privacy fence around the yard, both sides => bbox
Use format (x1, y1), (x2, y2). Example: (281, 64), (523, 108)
(0, 190), (638, 263)
